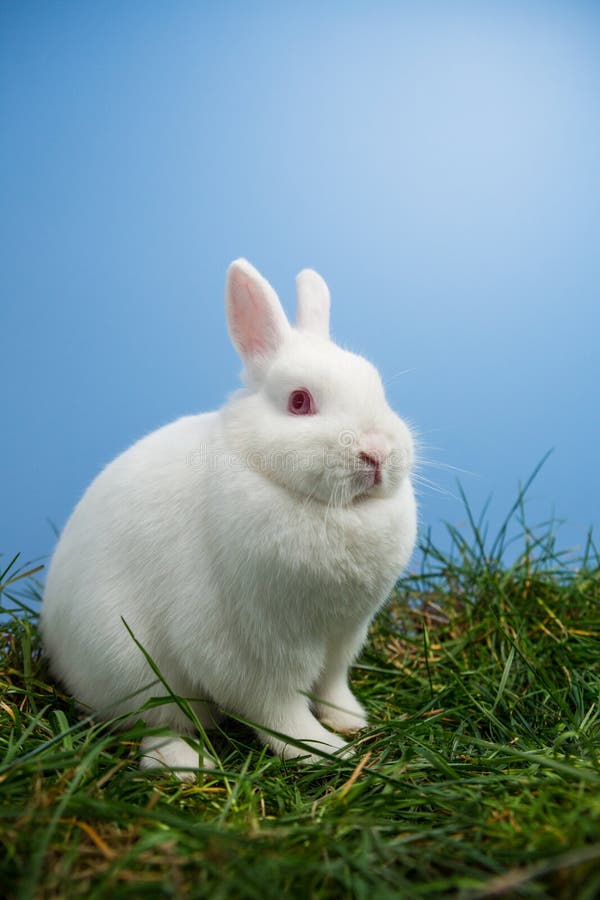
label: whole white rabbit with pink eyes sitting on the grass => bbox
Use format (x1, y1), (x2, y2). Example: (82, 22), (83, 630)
(41, 259), (416, 778)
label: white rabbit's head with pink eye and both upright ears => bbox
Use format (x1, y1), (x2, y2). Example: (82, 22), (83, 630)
(226, 260), (414, 507)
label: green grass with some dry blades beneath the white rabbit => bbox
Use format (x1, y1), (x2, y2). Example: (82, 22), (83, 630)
(0, 474), (600, 900)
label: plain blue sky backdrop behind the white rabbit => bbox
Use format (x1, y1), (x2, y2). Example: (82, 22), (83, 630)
(0, 0), (600, 572)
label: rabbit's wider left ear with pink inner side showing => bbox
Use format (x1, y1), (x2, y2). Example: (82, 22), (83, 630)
(225, 259), (290, 374)
